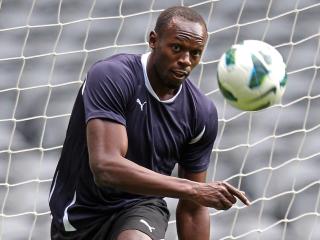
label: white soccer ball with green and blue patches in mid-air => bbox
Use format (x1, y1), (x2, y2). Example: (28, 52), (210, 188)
(217, 40), (287, 111)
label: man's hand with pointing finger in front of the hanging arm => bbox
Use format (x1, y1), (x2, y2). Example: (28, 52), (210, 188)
(194, 182), (250, 210)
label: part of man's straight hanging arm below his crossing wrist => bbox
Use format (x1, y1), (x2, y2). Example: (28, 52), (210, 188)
(176, 201), (210, 240)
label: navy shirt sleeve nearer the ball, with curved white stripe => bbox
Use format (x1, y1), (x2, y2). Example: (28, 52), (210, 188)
(179, 102), (218, 172)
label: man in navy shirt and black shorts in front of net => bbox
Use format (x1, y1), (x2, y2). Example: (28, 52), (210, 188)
(49, 7), (249, 240)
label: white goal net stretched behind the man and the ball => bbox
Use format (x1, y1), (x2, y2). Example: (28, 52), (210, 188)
(0, 0), (320, 240)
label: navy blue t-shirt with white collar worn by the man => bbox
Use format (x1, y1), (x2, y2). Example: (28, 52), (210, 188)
(49, 54), (218, 231)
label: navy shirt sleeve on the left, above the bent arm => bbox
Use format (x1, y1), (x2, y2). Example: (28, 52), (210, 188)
(82, 60), (132, 125)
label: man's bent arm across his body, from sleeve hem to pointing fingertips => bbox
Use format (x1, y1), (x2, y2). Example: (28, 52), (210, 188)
(87, 119), (249, 209)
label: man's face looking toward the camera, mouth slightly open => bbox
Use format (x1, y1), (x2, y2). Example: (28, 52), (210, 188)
(150, 17), (207, 89)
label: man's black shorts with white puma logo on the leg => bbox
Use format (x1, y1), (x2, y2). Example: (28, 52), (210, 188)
(51, 199), (170, 240)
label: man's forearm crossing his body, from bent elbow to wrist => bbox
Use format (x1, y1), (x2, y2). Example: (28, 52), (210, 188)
(93, 157), (199, 199)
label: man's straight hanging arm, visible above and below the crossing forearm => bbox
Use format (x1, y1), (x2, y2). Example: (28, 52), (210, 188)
(176, 166), (210, 240)
